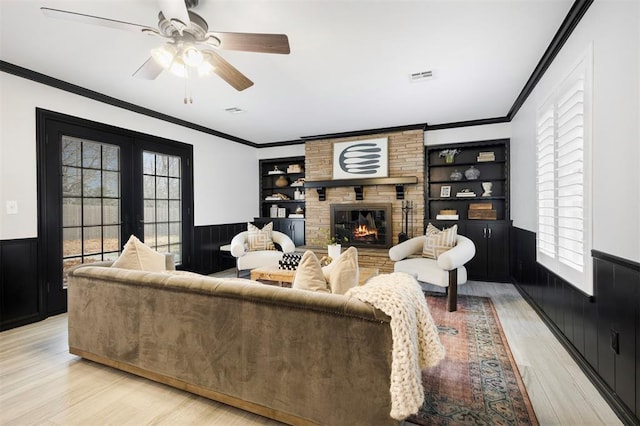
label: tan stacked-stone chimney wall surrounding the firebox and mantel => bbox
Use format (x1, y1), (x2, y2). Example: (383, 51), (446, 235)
(305, 128), (424, 272)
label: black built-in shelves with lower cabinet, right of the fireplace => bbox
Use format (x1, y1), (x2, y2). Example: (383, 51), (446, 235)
(424, 139), (511, 282)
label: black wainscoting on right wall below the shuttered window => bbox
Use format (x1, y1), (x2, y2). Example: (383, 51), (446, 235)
(511, 227), (640, 424)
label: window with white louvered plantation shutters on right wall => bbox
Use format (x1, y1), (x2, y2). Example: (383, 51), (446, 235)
(536, 47), (593, 295)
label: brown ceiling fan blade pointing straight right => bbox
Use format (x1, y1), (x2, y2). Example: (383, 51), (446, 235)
(207, 32), (291, 55)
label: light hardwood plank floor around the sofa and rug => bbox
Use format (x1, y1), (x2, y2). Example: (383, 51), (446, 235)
(0, 270), (621, 426)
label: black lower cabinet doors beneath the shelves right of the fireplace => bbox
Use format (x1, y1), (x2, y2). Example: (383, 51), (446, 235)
(464, 221), (510, 282)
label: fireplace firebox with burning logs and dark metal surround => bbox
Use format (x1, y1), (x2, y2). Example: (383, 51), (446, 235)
(331, 203), (393, 248)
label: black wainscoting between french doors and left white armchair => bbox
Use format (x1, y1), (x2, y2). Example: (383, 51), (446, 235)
(192, 222), (247, 274)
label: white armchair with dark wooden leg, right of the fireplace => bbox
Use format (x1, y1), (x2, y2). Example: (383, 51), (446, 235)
(389, 235), (476, 312)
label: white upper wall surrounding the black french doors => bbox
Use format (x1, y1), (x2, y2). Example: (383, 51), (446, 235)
(0, 73), (258, 239)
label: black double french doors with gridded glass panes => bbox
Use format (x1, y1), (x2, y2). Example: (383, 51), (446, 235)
(37, 110), (193, 316)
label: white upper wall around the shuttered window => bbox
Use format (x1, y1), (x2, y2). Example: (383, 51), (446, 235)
(511, 0), (640, 262)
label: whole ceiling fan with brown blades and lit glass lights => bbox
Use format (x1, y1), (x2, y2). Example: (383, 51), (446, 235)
(40, 0), (290, 95)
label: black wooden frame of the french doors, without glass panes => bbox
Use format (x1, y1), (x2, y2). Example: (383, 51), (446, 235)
(36, 108), (194, 319)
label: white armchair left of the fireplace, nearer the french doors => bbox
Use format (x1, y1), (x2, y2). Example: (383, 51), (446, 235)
(231, 231), (296, 276)
